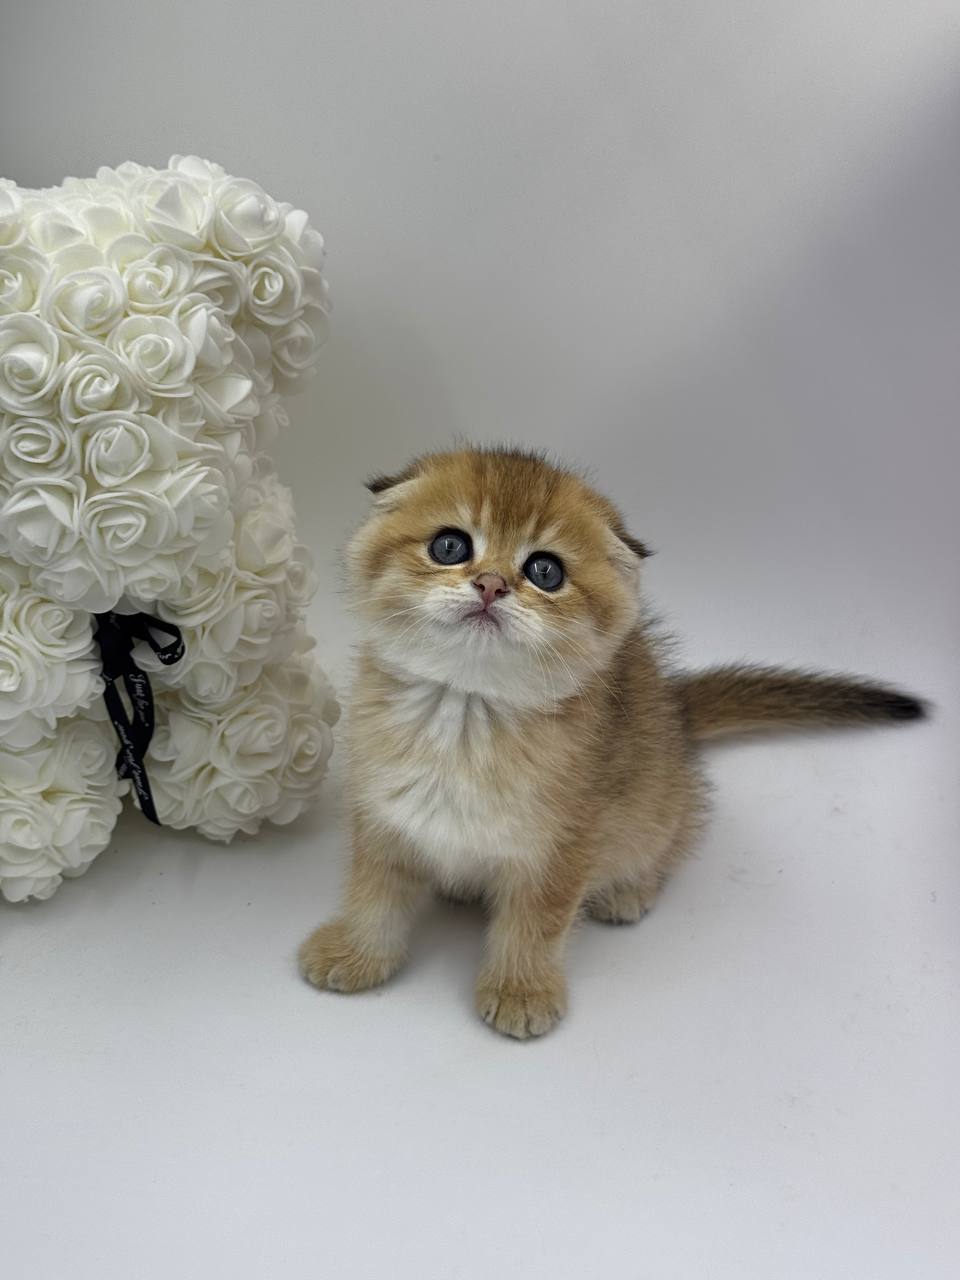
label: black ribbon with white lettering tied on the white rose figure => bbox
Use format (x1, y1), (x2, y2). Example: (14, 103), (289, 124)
(93, 613), (183, 827)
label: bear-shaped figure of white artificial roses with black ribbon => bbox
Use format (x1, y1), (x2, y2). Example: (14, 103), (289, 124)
(0, 156), (337, 901)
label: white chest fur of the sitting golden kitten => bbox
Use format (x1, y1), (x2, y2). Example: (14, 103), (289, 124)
(358, 682), (545, 881)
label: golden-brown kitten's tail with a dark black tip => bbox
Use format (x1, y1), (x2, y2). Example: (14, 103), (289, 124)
(673, 666), (928, 739)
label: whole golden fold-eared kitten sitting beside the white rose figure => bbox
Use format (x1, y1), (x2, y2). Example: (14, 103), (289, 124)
(300, 451), (924, 1038)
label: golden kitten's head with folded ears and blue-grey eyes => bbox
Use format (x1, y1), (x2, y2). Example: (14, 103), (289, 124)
(349, 449), (646, 707)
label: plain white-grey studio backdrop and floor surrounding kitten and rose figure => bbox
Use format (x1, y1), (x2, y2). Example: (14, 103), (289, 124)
(0, 0), (960, 1280)
